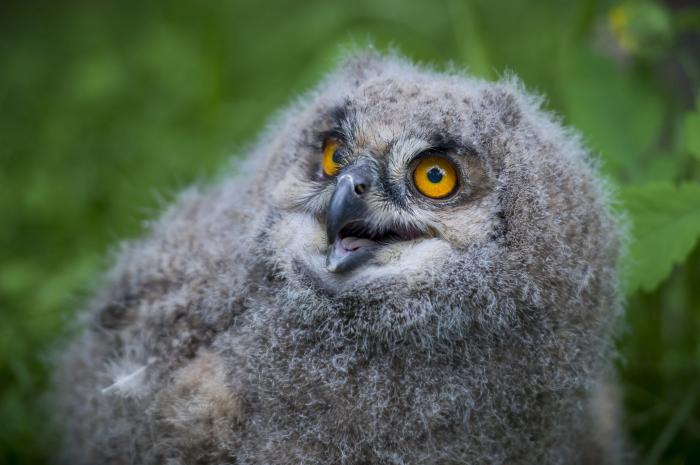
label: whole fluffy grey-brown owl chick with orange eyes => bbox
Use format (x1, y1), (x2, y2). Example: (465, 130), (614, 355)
(54, 52), (621, 465)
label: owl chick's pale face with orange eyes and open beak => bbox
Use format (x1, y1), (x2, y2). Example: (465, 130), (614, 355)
(266, 72), (498, 280)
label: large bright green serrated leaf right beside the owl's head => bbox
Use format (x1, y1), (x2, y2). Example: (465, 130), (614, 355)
(622, 184), (700, 293)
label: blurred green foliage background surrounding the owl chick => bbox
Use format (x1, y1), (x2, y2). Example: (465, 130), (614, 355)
(0, 0), (700, 464)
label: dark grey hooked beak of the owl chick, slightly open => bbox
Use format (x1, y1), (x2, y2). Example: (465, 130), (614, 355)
(326, 165), (378, 273)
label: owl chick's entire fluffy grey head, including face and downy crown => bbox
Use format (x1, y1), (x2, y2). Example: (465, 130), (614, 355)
(250, 54), (617, 348)
